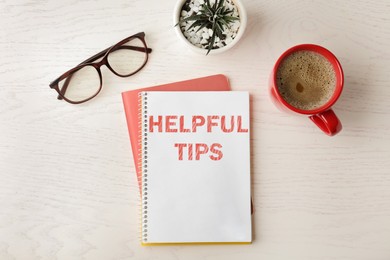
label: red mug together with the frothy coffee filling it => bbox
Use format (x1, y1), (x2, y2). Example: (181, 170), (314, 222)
(269, 44), (344, 136)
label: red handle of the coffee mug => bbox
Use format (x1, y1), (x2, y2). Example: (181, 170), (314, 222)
(309, 109), (343, 136)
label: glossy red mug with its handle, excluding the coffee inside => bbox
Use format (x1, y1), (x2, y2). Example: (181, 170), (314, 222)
(269, 44), (344, 136)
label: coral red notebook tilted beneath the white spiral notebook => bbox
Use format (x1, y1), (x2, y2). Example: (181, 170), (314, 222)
(122, 74), (230, 192)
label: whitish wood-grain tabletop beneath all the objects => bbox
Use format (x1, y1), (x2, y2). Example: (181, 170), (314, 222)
(0, 0), (390, 260)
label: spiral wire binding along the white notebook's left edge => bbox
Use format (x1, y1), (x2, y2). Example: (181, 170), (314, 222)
(138, 92), (148, 243)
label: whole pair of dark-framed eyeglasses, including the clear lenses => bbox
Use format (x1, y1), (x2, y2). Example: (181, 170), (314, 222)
(50, 32), (152, 104)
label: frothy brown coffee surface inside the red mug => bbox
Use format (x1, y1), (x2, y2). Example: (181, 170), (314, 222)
(276, 51), (336, 110)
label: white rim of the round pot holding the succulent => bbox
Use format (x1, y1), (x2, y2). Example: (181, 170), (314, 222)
(173, 0), (248, 55)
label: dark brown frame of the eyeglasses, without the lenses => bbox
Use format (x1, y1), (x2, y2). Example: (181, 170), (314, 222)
(49, 32), (152, 104)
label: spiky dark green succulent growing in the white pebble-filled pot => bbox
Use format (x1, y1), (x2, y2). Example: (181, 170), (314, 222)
(175, 0), (239, 55)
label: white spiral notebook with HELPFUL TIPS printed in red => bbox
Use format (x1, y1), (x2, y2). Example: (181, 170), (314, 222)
(138, 91), (252, 245)
